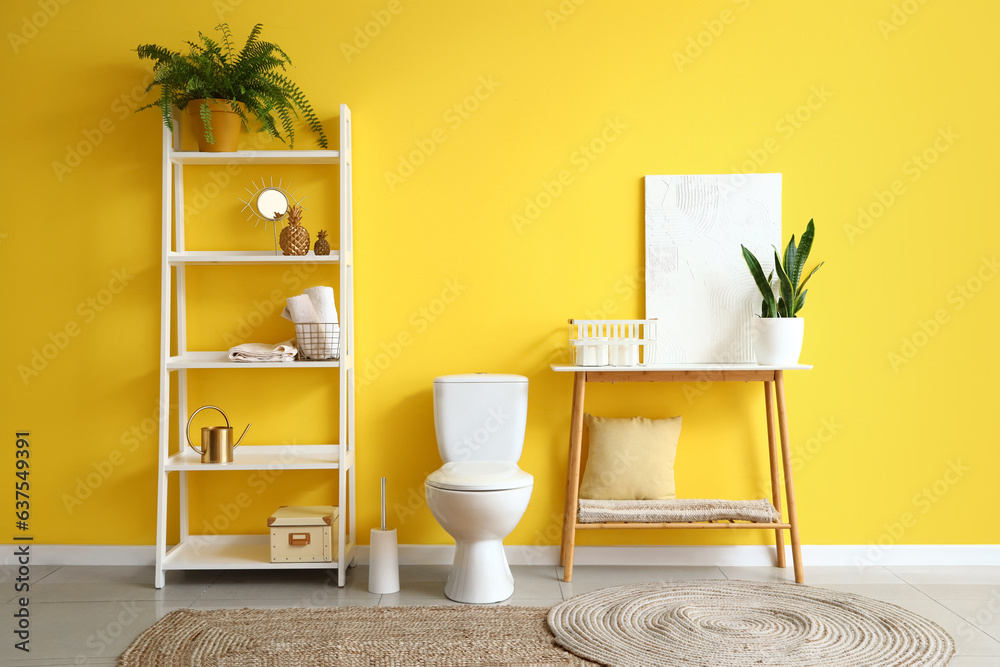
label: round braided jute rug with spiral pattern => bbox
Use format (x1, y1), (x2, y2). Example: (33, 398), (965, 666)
(548, 580), (955, 667)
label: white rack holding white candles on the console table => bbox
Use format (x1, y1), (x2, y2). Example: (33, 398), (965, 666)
(569, 319), (656, 366)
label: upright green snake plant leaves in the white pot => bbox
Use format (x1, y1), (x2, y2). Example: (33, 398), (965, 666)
(740, 220), (824, 317)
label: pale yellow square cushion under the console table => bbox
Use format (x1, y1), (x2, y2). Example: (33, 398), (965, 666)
(580, 414), (681, 500)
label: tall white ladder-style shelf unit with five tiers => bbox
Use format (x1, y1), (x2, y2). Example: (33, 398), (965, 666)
(154, 104), (357, 588)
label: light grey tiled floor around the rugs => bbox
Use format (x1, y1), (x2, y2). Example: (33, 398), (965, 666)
(0, 566), (1000, 667)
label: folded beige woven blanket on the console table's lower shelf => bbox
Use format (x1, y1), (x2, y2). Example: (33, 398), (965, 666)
(578, 498), (781, 523)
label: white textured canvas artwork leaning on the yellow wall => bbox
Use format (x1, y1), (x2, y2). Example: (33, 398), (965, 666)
(646, 174), (781, 364)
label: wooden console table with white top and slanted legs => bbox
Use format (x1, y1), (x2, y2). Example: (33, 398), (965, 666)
(552, 364), (812, 584)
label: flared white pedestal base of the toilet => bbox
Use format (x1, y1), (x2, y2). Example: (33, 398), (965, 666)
(444, 540), (514, 604)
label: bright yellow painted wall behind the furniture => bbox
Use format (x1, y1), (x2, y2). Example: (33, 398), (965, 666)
(0, 0), (1000, 545)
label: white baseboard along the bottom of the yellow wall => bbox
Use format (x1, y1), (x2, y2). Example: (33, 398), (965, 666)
(0, 543), (1000, 567)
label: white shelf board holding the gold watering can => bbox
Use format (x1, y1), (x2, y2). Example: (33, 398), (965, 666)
(163, 445), (352, 472)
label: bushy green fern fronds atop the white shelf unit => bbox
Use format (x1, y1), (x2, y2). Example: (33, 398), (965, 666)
(136, 23), (327, 148)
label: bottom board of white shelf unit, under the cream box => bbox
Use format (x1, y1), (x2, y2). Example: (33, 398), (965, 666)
(163, 535), (356, 570)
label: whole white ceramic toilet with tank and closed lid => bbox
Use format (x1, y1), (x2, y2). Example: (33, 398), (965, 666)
(424, 373), (535, 604)
